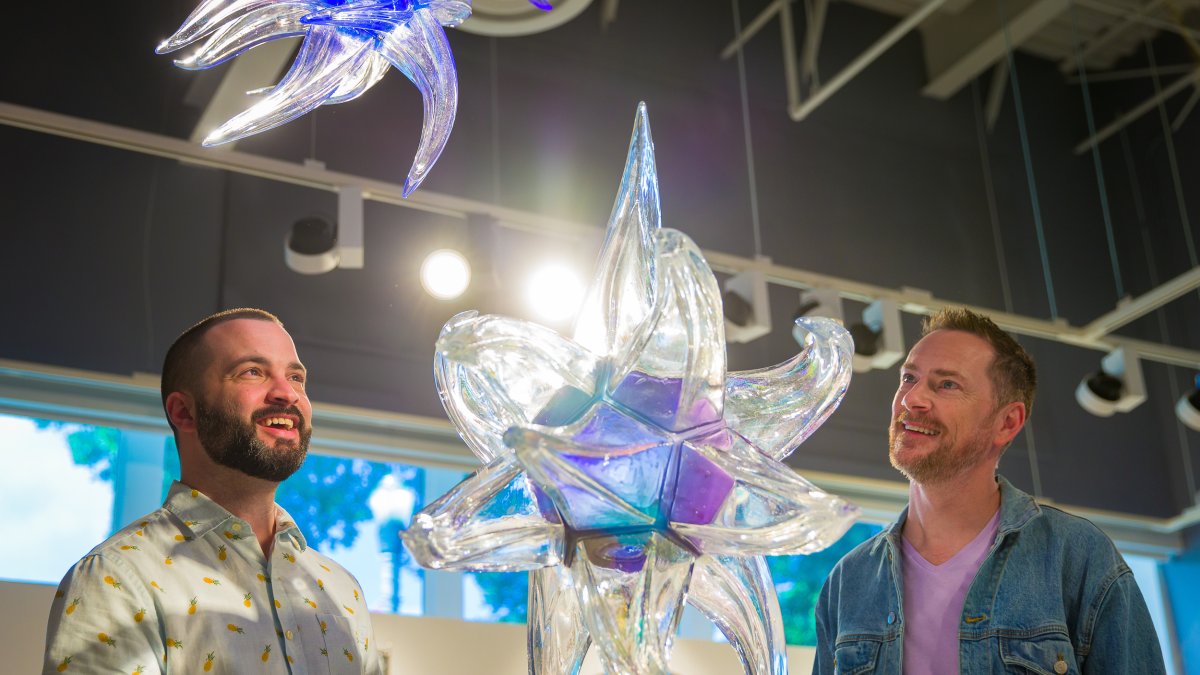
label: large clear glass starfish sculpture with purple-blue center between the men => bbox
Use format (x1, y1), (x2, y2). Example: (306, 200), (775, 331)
(403, 104), (857, 675)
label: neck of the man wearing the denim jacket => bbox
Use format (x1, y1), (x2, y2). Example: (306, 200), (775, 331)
(902, 467), (1000, 565)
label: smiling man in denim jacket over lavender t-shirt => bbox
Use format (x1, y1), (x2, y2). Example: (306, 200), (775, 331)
(814, 309), (1164, 675)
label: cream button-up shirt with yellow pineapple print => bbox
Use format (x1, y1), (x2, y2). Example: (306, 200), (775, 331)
(43, 482), (383, 675)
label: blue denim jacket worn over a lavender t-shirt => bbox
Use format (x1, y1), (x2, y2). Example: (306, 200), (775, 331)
(812, 477), (1165, 675)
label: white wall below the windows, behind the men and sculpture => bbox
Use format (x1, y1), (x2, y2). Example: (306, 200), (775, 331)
(0, 581), (812, 675)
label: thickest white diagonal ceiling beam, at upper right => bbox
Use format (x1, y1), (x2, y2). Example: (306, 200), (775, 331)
(922, 0), (1070, 101)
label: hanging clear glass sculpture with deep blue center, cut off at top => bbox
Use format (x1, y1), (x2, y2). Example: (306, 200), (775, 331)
(156, 0), (470, 197)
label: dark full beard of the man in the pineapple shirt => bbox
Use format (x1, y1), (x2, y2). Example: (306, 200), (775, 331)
(196, 399), (312, 483)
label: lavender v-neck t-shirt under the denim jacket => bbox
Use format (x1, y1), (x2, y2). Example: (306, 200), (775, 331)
(900, 510), (1000, 675)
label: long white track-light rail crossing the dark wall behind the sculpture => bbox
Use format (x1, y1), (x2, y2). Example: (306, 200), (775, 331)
(0, 100), (1200, 369)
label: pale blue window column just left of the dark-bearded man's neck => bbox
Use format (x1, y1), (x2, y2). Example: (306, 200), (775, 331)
(113, 430), (167, 531)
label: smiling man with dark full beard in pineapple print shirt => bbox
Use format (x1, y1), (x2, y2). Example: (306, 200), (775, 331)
(43, 309), (382, 674)
